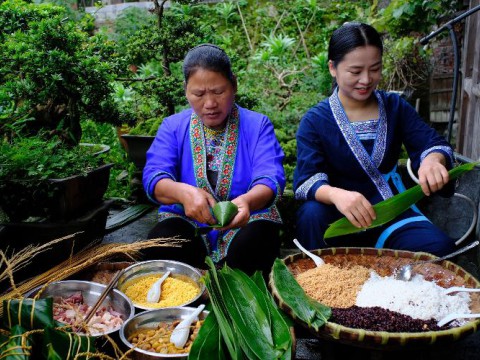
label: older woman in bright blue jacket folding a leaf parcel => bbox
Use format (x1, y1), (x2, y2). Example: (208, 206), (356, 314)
(143, 44), (285, 273)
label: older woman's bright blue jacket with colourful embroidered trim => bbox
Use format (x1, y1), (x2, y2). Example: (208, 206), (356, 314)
(143, 106), (285, 261)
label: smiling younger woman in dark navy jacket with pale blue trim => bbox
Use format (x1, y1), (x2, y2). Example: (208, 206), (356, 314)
(294, 23), (454, 255)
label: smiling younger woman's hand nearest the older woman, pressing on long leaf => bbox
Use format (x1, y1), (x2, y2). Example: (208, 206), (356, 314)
(315, 185), (376, 228)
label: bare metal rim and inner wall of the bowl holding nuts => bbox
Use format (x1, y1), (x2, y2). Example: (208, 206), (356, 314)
(119, 307), (208, 360)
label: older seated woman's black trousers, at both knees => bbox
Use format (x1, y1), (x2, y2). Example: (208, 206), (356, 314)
(144, 218), (280, 275)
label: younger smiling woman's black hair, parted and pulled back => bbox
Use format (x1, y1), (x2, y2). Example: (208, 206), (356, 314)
(328, 22), (383, 67)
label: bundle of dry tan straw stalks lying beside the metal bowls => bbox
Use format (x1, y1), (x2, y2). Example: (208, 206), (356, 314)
(0, 238), (185, 316)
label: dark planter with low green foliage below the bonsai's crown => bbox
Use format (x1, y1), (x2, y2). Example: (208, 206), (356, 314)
(0, 135), (110, 222)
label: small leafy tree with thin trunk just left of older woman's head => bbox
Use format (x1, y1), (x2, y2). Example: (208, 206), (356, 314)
(115, 0), (204, 122)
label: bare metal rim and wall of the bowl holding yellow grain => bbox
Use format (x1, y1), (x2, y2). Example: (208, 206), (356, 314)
(117, 260), (205, 310)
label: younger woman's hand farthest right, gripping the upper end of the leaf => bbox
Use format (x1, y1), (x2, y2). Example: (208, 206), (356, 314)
(418, 153), (449, 196)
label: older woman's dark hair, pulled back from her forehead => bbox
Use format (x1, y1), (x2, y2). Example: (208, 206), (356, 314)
(183, 44), (236, 86)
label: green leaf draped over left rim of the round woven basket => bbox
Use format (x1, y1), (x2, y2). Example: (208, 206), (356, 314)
(272, 259), (332, 331)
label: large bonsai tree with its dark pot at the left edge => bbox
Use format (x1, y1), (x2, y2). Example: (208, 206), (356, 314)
(0, 0), (118, 228)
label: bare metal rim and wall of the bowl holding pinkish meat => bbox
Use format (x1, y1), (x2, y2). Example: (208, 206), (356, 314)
(25, 280), (135, 336)
